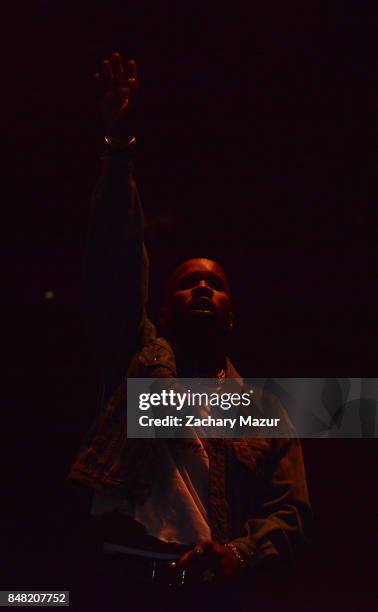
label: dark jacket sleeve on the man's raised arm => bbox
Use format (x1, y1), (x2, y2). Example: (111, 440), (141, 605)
(84, 151), (155, 382)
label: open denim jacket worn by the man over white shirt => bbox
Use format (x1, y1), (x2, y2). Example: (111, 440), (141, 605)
(68, 153), (311, 567)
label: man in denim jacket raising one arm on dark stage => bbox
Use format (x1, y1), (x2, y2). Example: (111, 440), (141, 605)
(69, 54), (311, 583)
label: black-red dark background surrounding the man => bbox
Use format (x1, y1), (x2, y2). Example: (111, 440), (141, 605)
(1, 0), (378, 610)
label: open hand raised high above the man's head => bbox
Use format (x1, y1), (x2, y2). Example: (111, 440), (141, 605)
(95, 53), (138, 138)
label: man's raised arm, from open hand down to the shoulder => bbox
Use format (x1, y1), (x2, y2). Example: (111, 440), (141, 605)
(85, 53), (155, 383)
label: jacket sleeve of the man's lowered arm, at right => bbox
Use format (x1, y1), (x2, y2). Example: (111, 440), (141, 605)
(232, 438), (312, 568)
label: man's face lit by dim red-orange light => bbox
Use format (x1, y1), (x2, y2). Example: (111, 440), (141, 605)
(162, 259), (232, 330)
